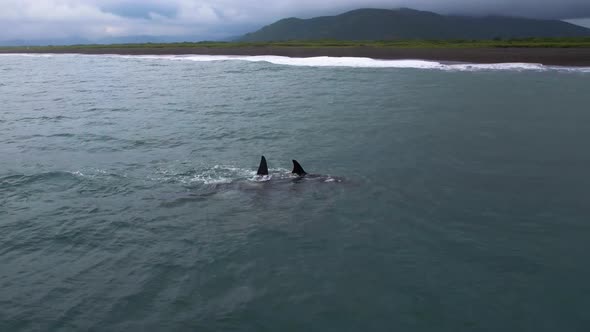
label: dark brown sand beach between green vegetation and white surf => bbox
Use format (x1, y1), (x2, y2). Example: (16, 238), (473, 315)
(0, 46), (590, 67)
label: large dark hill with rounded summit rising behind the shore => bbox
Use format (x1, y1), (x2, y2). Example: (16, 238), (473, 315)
(238, 9), (590, 41)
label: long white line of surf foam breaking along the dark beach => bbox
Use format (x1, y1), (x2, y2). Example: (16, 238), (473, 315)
(0, 53), (590, 73)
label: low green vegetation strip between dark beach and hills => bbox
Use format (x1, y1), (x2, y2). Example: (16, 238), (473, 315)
(0, 37), (590, 52)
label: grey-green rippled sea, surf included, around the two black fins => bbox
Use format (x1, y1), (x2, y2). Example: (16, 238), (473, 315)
(0, 55), (590, 331)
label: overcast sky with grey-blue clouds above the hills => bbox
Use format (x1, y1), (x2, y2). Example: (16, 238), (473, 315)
(0, 0), (590, 40)
